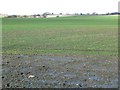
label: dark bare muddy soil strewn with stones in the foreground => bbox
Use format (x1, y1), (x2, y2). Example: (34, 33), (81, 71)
(2, 55), (118, 88)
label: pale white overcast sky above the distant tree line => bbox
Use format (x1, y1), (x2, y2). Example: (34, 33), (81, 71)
(0, 0), (120, 14)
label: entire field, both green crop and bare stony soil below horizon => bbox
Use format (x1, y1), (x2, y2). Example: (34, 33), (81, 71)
(2, 16), (118, 87)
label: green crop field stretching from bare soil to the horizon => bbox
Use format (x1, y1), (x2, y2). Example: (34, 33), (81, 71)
(2, 16), (118, 56)
